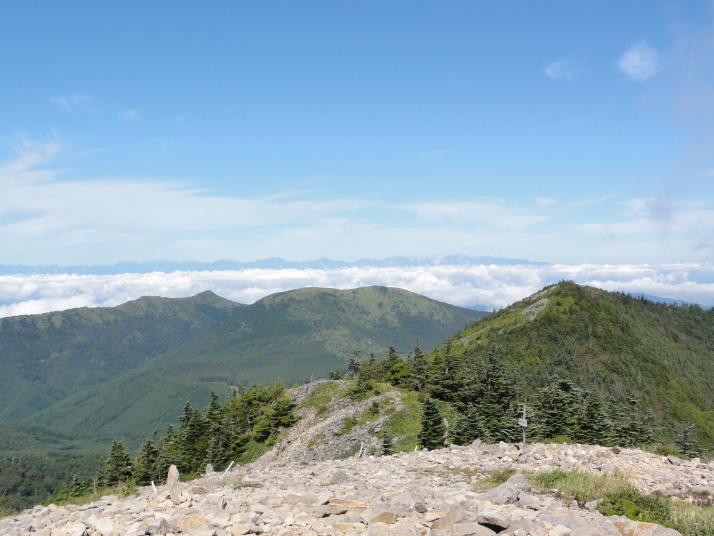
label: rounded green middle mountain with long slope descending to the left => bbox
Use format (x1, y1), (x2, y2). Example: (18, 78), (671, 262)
(27, 287), (485, 444)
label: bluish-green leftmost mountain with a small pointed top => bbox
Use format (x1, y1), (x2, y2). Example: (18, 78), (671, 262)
(0, 292), (242, 420)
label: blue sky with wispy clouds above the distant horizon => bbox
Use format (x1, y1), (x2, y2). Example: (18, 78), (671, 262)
(0, 0), (714, 264)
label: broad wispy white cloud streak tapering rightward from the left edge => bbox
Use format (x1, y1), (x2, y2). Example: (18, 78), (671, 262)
(0, 142), (374, 248)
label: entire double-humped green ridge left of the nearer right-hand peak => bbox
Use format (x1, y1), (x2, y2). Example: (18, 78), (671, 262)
(0, 286), (485, 445)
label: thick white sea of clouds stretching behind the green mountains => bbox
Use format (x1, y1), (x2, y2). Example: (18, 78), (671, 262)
(0, 263), (714, 317)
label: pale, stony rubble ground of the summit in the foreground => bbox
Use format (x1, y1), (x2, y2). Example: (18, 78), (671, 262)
(0, 441), (700, 536)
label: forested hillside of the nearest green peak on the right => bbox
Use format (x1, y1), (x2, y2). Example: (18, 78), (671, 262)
(433, 282), (714, 451)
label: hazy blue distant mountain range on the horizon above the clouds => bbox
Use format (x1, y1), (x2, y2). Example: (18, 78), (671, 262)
(0, 255), (550, 275)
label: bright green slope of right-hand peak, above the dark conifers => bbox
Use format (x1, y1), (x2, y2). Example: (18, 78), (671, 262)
(435, 282), (714, 450)
